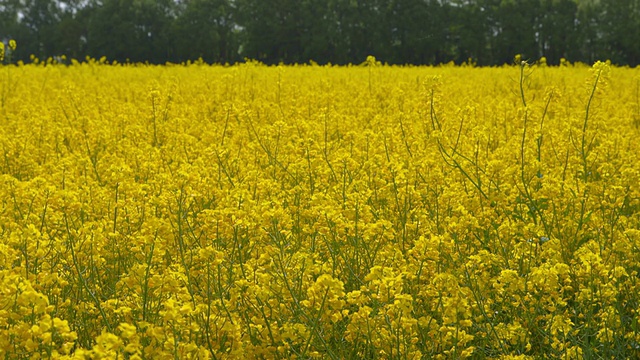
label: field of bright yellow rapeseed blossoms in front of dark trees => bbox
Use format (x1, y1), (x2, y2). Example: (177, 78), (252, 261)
(0, 54), (640, 359)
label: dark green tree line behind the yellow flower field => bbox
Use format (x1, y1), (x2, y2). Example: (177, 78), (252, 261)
(0, 0), (640, 66)
